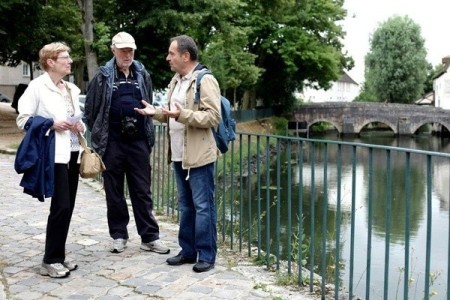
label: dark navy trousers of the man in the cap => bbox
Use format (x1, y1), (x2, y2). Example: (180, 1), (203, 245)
(103, 138), (159, 243)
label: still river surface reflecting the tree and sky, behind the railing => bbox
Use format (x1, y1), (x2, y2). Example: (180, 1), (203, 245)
(243, 136), (450, 299)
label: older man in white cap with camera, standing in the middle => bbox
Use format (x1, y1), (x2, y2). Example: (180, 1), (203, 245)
(83, 32), (170, 254)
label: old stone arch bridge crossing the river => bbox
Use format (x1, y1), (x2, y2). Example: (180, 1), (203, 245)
(289, 102), (450, 135)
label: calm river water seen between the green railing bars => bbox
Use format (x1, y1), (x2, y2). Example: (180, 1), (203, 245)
(244, 134), (450, 299)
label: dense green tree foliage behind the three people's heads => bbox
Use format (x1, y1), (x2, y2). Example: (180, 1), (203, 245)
(0, 0), (353, 111)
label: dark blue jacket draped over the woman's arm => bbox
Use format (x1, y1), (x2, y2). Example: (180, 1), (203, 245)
(14, 116), (55, 201)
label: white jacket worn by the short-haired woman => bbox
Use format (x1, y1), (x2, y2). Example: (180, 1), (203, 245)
(16, 72), (86, 164)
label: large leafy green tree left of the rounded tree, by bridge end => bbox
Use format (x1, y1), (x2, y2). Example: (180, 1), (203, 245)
(244, 0), (353, 111)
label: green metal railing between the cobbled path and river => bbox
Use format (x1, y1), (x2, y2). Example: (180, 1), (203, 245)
(131, 125), (450, 299)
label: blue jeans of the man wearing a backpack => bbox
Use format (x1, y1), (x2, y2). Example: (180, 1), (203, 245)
(174, 162), (217, 264)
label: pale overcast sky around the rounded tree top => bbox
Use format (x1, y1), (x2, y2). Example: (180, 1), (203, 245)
(344, 0), (450, 83)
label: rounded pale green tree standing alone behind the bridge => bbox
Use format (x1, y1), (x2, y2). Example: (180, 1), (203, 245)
(365, 16), (428, 103)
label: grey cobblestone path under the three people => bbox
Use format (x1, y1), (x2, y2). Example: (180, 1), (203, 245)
(0, 151), (318, 300)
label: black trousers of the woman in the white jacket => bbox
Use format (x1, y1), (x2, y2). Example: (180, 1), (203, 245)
(44, 151), (80, 264)
